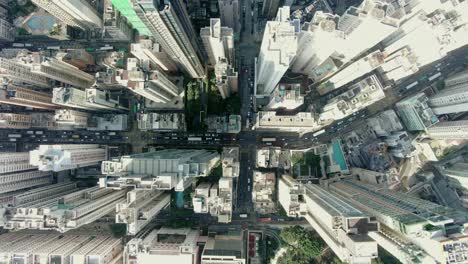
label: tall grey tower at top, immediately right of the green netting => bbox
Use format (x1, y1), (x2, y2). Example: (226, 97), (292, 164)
(134, 0), (205, 78)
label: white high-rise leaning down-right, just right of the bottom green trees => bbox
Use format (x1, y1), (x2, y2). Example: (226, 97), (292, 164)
(278, 175), (379, 263)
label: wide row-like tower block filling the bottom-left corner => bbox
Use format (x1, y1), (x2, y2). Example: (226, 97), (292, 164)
(0, 231), (122, 264)
